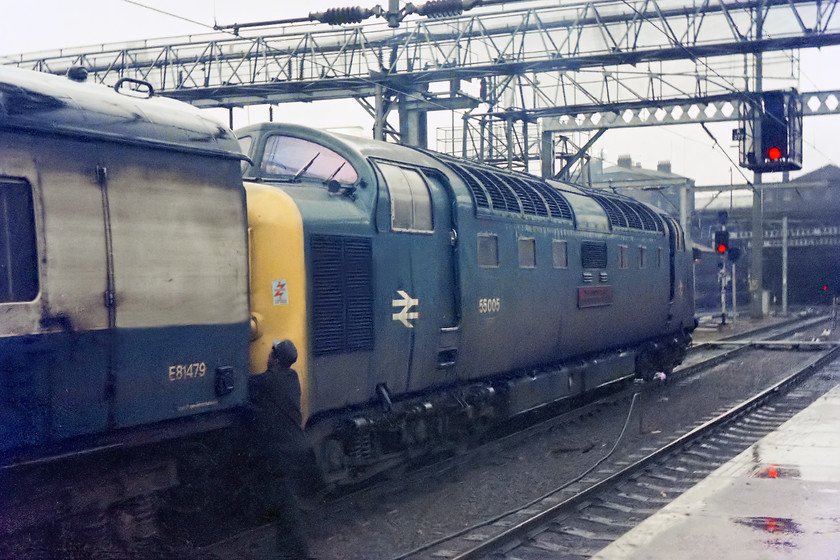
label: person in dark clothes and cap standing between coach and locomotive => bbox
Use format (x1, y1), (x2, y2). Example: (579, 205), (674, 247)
(248, 340), (313, 559)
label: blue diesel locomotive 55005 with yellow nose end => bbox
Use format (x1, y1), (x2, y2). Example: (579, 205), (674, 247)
(237, 123), (695, 480)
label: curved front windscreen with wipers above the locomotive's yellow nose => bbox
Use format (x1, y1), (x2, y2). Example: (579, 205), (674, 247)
(260, 135), (359, 185)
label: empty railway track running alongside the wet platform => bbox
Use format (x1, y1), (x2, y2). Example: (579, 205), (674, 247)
(395, 320), (840, 560)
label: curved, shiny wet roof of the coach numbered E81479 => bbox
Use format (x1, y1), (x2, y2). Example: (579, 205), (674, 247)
(0, 67), (244, 159)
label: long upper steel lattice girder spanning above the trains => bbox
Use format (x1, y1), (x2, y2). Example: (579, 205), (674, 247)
(0, 0), (840, 109)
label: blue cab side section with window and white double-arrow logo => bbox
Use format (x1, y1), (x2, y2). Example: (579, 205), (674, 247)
(375, 161), (460, 392)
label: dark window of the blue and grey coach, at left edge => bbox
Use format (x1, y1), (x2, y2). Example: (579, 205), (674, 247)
(0, 179), (38, 303)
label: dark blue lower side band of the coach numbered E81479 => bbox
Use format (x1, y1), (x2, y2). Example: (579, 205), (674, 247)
(0, 323), (249, 454)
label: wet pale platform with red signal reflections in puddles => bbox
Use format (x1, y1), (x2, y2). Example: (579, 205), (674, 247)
(593, 386), (840, 560)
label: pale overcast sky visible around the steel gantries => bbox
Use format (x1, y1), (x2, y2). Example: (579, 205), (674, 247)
(0, 0), (840, 189)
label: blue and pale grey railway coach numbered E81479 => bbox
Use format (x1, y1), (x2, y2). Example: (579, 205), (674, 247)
(0, 68), (250, 556)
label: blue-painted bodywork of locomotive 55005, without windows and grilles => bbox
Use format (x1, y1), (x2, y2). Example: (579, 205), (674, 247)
(238, 124), (693, 426)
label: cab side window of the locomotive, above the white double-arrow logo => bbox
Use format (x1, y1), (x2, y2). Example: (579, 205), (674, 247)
(379, 162), (434, 232)
